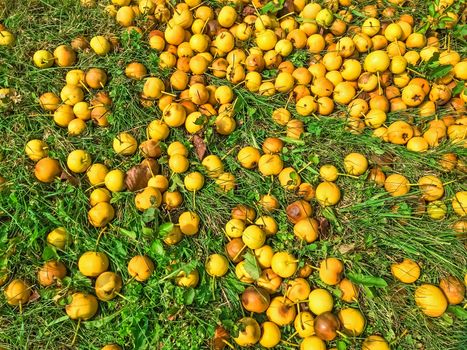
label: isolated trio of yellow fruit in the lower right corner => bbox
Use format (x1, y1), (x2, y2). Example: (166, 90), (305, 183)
(391, 259), (465, 317)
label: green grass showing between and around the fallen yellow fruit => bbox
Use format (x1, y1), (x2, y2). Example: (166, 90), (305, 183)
(0, 0), (467, 350)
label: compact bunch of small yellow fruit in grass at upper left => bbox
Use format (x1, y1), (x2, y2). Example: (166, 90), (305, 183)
(35, 65), (112, 136)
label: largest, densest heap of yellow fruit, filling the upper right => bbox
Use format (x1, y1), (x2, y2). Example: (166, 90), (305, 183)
(102, 0), (467, 151)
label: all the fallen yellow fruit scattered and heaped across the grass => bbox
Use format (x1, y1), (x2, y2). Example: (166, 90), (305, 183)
(0, 0), (467, 350)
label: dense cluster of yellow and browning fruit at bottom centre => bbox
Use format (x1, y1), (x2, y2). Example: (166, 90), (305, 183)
(205, 204), (389, 349)
